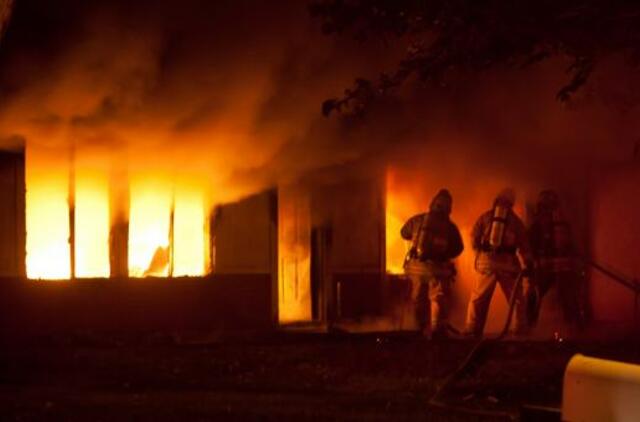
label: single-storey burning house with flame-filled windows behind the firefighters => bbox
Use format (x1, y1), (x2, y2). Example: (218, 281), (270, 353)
(0, 139), (637, 342)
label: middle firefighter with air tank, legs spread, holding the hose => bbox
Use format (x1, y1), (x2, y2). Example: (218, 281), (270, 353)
(464, 189), (533, 337)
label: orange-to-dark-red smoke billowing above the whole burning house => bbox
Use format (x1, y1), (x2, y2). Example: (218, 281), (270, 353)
(0, 0), (639, 203)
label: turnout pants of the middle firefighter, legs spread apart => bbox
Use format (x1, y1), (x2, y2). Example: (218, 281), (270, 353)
(465, 271), (527, 336)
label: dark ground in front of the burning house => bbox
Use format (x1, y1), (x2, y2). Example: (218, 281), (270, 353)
(0, 333), (640, 421)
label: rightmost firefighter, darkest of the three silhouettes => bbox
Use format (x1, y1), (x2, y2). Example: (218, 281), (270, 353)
(529, 189), (582, 327)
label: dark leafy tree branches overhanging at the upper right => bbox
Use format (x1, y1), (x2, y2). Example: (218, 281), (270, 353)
(310, 0), (640, 115)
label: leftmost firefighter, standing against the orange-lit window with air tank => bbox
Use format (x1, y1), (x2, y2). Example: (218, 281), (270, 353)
(400, 189), (464, 339)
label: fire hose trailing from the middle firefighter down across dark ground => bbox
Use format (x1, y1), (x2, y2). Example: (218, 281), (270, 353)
(429, 271), (524, 420)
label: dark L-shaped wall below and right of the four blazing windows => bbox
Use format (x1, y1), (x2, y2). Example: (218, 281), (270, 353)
(0, 188), (277, 339)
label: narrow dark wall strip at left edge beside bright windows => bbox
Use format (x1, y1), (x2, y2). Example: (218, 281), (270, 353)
(0, 151), (26, 277)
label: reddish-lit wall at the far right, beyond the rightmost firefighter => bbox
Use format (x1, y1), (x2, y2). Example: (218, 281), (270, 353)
(590, 163), (640, 331)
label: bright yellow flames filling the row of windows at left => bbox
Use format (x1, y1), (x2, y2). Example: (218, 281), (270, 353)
(26, 147), (210, 280)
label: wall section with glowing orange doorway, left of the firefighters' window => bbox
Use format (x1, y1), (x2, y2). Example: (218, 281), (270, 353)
(278, 174), (384, 323)
